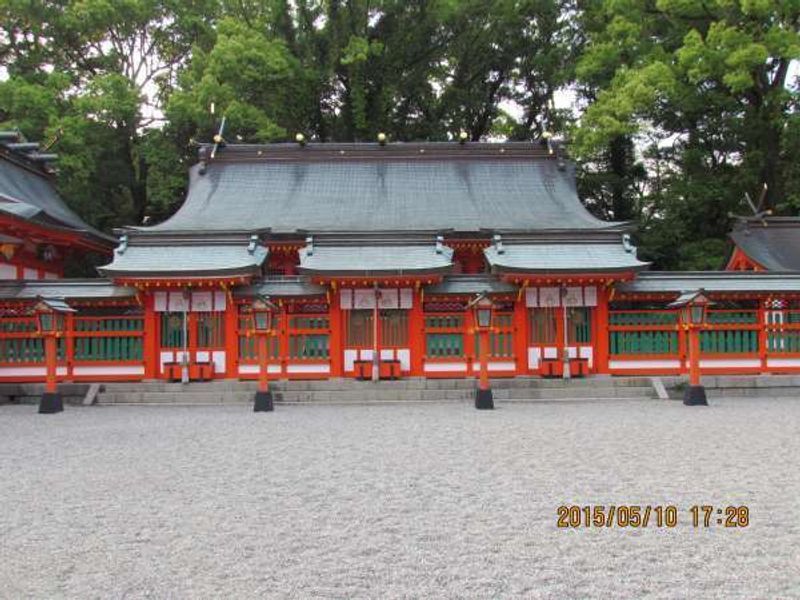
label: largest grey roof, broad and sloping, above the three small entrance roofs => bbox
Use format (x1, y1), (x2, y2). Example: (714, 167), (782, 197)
(144, 143), (620, 233)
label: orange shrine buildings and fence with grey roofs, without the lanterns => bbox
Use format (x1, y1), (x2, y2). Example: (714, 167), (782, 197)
(0, 134), (800, 382)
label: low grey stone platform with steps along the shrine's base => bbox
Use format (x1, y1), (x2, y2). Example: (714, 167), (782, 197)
(6, 375), (800, 405)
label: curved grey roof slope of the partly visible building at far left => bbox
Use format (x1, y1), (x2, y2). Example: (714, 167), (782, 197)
(0, 149), (112, 241)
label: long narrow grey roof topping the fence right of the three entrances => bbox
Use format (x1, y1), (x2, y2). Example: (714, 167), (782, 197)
(617, 271), (800, 294)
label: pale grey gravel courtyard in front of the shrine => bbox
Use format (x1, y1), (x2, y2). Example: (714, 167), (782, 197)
(0, 399), (800, 598)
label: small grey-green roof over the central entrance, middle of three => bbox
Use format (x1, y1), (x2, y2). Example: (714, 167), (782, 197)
(300, 244), (453, 275)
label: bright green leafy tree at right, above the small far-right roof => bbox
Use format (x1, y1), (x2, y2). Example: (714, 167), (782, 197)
(573, 0), (800, 267)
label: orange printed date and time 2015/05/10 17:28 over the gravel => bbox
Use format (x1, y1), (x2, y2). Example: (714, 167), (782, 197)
(556, 504), (750, 529)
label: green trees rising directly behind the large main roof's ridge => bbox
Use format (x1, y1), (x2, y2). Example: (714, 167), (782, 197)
(168, 0), (576, 141)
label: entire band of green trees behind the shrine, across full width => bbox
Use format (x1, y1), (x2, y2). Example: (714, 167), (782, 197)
(0, 0), (800, 268)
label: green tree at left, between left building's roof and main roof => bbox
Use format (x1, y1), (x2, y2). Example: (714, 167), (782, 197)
(0, 0), (216, 229)
